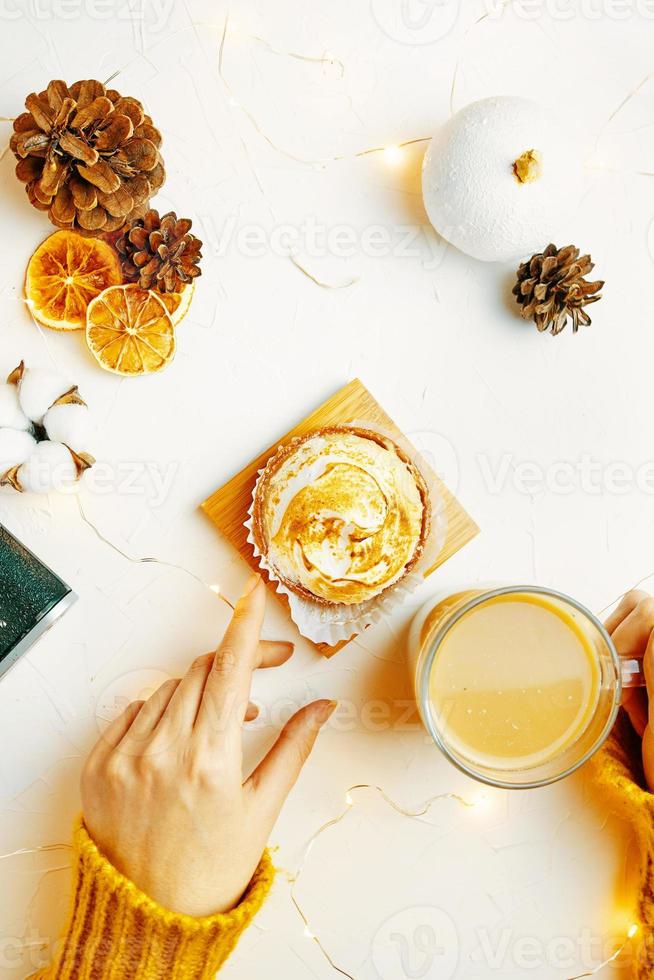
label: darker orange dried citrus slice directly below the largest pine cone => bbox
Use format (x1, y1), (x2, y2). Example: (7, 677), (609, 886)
(25, 231), (123, 330)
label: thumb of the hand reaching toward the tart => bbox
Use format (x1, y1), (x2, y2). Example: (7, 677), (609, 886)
(245, 701), (336, 819)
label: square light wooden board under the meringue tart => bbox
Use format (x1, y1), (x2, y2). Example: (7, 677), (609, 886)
(202, 378), (479, 657)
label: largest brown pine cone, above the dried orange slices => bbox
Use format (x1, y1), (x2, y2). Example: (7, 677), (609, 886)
(10, 79), (165, 234)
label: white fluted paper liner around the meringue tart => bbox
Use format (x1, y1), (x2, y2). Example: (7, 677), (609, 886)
(245, 419), (447, 646)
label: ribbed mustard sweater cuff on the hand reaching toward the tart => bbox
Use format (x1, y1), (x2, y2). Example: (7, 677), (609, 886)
(27, 821), (274, 980)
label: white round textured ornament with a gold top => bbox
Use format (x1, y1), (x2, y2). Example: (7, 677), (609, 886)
(422, 96), (582, 262)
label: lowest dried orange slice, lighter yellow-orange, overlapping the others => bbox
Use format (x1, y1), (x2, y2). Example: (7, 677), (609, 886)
(86, 285), (175, 377)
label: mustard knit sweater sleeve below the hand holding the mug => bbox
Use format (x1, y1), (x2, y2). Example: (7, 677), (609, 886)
(590, 712), (654, 980)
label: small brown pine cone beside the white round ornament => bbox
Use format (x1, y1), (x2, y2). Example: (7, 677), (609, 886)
(513, 245), (604, 336)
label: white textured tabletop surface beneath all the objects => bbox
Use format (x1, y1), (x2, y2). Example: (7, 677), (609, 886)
(0, 0), (654, 980)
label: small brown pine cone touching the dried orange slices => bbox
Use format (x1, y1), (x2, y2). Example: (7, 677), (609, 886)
(116, 209), (202, 293)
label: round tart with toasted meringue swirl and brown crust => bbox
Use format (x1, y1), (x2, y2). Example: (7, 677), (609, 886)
(261, 429), (425, 604)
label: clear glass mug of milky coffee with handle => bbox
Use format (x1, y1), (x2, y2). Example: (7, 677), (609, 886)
(409, 585), (644, 789)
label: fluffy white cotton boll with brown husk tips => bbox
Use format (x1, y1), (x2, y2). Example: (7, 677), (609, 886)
(0, 361), (95, 493)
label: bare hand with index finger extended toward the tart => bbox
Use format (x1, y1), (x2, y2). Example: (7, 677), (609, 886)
(82, 576), (336, 916)
